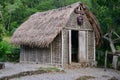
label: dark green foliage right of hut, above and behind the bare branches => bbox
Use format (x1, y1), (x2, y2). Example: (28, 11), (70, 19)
(91, 0), (120, 66)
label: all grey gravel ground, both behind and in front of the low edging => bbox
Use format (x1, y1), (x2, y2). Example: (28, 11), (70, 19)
(0, 63), (120, 80)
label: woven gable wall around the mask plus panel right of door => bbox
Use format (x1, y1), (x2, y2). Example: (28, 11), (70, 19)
(65, 12), (95, 62)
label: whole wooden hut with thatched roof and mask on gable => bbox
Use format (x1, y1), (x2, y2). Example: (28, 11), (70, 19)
(11, 3), (101, 65)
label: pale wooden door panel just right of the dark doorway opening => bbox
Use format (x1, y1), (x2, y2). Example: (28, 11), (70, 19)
(78, 31), (87, 62)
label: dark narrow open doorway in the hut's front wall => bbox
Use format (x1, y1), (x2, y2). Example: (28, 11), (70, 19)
(71, 30), (78, 62)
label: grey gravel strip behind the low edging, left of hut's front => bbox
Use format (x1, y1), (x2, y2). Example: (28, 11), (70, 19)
(0, 62), (53, 77)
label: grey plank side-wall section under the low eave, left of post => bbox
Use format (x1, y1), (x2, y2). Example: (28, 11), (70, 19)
(20, 46), (51, 64)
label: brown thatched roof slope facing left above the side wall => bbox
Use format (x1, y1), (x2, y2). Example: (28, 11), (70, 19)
(11, 3), (101, 47)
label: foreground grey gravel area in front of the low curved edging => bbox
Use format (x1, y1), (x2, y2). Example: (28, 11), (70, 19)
(11, 68), (120, 80)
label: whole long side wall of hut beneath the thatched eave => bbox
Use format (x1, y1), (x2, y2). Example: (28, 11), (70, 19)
(20, 33), (62, 65)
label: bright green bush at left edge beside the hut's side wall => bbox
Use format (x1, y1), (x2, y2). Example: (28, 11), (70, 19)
(0, 41), (20, 62)
